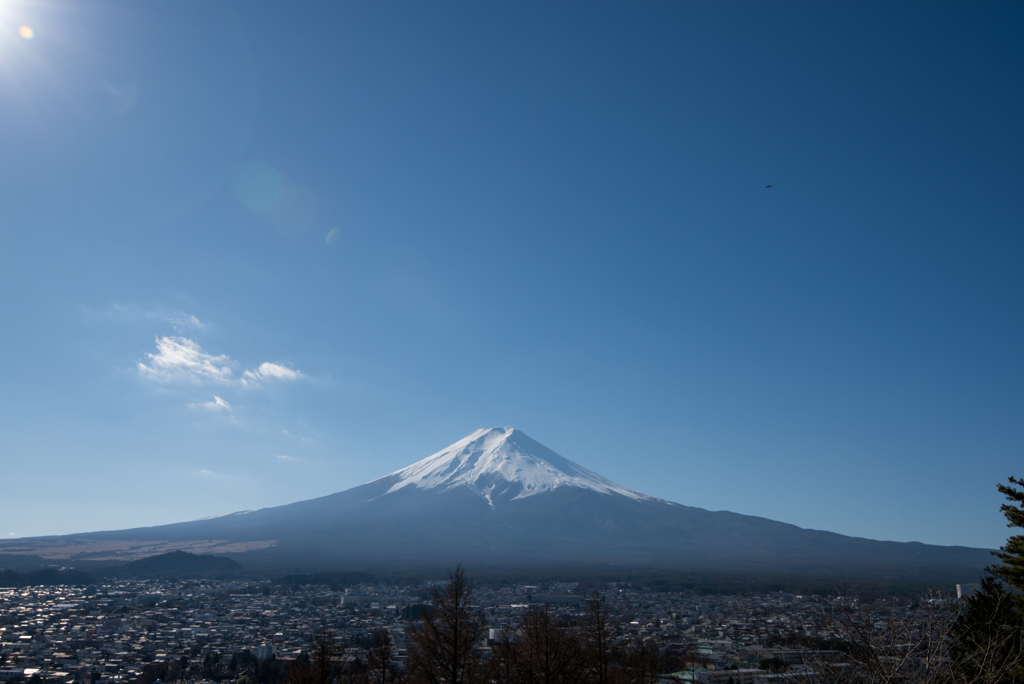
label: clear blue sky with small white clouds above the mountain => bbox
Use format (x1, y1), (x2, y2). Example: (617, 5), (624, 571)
(0, 0), (1024, 547)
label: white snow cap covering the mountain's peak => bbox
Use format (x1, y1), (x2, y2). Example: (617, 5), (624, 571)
(374, 427), (653, 506)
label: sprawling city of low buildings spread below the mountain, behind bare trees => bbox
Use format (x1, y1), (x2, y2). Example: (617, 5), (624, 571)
(0, 581), (942, 684)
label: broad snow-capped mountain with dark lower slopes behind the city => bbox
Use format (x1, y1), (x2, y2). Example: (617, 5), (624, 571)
(0, 427), (991, 585)
